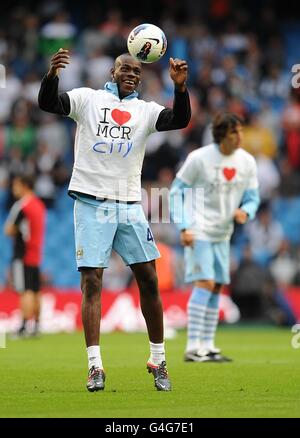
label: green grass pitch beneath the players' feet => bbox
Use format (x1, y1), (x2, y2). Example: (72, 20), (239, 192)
(0, 327), (300, 418)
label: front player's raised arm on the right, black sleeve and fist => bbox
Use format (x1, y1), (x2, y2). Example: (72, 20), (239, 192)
(156, 58), (191, 131)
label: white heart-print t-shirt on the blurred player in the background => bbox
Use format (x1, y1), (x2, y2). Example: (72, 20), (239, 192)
(177, 143), (258, 242)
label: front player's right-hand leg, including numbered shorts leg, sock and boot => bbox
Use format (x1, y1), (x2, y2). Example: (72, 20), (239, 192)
(114, 204), (171, 391)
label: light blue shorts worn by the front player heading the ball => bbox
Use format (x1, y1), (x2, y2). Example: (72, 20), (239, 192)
(74, 199), (160, 268)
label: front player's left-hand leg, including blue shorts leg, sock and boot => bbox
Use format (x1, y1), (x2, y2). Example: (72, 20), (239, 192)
(74, 200), (117, 392)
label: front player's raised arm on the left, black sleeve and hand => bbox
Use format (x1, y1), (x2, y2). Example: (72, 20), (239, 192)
(38, 49), (70, 116)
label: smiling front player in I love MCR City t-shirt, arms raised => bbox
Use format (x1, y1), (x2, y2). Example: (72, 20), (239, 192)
(39, 49), (191, 391)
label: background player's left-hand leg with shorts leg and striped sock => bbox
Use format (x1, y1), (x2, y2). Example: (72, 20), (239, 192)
(184, 240), (215, 362)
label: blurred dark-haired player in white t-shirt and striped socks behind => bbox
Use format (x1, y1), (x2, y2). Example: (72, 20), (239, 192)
(170, 113), (259, 362)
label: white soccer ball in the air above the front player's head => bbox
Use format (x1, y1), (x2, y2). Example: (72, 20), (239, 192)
(127, 23), (167, 64)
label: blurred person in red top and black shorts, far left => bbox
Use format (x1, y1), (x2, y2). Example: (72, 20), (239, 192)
(4, 175), (46, 336)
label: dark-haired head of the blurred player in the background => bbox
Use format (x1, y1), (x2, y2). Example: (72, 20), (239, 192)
(212, 112), (243, 152)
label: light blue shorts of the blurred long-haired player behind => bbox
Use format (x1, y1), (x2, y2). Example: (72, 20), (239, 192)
(184, 240), (230, 284)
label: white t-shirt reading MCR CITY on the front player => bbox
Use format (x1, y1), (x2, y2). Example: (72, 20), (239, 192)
(68, 88), (164, 201)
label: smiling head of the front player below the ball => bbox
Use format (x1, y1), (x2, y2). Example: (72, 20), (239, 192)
(111, 53), (142, 97)
